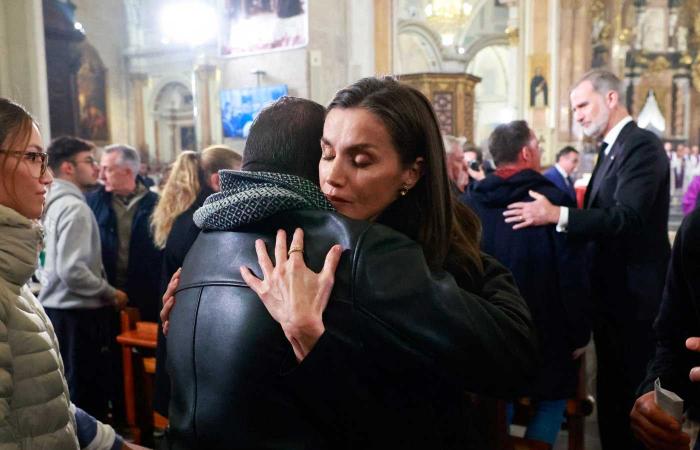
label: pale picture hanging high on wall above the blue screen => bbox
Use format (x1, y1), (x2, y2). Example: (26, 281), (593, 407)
(219, 0), (309, 57)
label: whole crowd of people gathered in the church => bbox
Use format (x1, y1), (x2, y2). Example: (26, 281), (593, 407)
(0, 70), (700, 450)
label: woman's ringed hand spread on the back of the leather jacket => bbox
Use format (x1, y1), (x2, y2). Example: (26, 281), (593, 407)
(238, 228), (342, 361)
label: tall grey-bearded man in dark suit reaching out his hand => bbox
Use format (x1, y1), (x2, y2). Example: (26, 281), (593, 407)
(504, 70), (670, 450)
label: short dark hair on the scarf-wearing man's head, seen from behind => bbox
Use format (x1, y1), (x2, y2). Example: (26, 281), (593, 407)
(242, 97), (325, 184)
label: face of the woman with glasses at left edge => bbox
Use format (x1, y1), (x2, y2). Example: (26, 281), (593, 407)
(0, 125), (53, 219)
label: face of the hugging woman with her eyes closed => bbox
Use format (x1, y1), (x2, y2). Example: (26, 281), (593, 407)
(318, 108), (423, 220)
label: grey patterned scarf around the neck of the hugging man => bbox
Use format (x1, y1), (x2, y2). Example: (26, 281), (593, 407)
(194, 170), (335, 231)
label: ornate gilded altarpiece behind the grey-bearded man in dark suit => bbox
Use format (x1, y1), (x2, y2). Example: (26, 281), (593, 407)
(589, 0), (700, 142)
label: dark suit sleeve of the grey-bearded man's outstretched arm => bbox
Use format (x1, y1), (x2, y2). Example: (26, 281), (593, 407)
(568, 133), (669, 237)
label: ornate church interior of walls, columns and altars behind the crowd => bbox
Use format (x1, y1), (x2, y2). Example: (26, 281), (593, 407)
(0, 0), (700, 449)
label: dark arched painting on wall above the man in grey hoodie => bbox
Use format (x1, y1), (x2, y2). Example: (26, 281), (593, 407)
(77, 43), (109, 143)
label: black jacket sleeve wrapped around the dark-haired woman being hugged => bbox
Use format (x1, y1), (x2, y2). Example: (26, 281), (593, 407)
(352, 225), (538, 396)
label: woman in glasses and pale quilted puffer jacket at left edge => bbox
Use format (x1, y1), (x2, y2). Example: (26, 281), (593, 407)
(0, 98), (140, 450)
